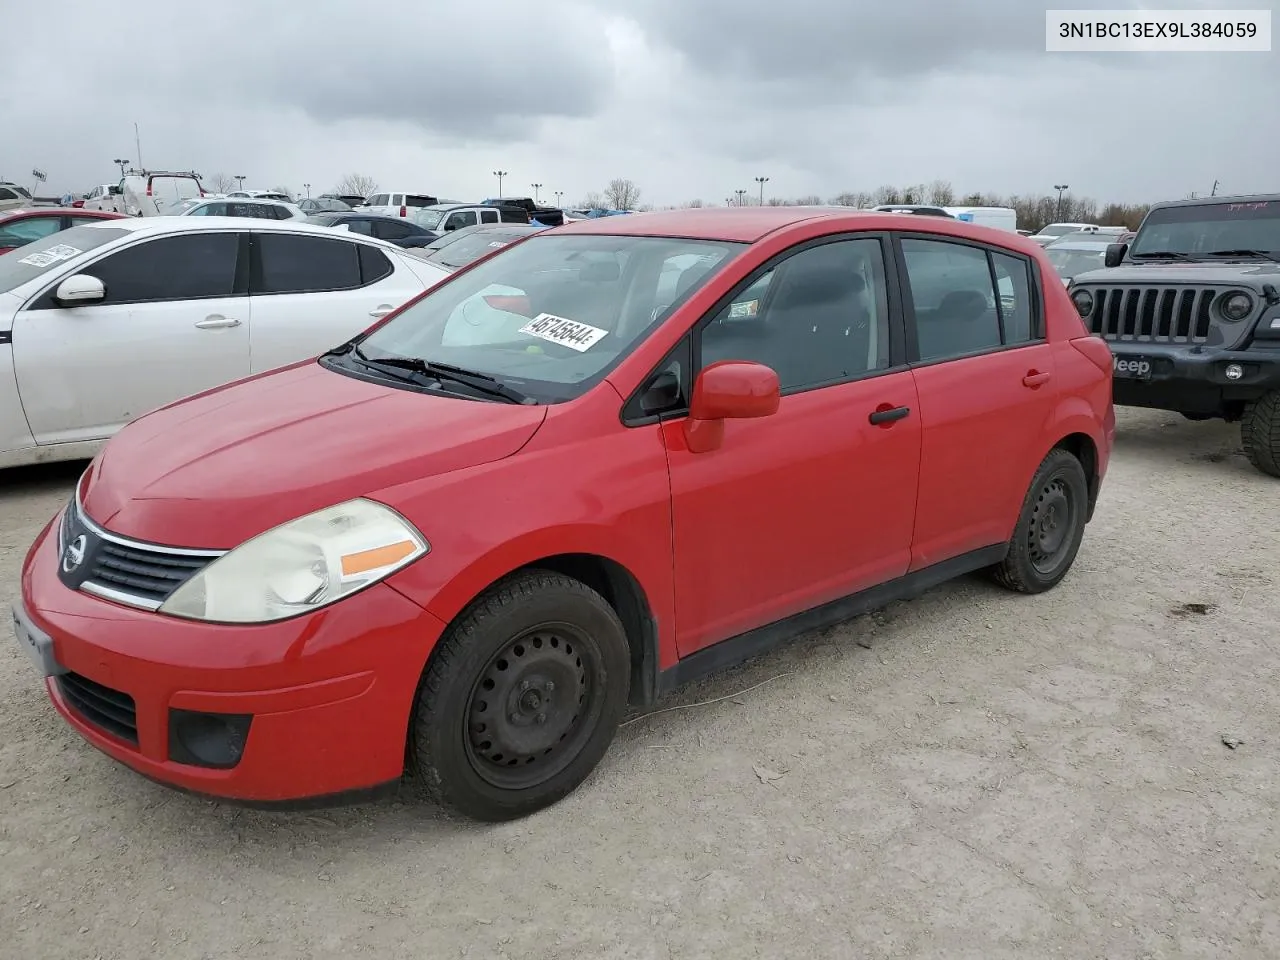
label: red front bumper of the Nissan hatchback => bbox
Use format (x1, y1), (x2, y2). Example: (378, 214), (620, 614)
(19, 524), (444, 803)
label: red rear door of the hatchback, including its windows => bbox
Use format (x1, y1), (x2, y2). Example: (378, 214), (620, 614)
(897, 234), (1056, 570)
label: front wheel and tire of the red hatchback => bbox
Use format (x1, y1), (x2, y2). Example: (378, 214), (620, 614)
(408, 571), (631, 823)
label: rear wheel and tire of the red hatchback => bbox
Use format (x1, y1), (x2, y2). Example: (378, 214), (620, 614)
(992, 449), (1089, 594)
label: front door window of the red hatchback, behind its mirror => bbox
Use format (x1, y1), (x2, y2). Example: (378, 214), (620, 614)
(701, 238), (888, 390)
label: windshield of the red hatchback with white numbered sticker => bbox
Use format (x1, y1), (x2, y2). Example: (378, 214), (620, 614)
(360, 236), (746, 403)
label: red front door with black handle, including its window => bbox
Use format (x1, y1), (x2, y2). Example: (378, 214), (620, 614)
(663, 237), (920, 657)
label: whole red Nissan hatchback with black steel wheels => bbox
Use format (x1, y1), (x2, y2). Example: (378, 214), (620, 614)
(14, 207), (1115, 820)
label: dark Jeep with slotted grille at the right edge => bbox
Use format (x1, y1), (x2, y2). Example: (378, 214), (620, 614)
(1068, 195), (1280, 476)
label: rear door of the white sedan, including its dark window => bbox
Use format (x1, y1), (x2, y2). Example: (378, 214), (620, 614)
(250, 230), (425, 372)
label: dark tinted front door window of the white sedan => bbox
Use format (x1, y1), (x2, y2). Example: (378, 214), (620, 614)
(81, 233), (239, 305)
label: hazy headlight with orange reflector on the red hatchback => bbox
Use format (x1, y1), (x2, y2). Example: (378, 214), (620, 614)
(160, 499), (430, 623)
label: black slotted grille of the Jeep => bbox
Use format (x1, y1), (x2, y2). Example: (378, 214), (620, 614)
(1085, 285), (1219, 343)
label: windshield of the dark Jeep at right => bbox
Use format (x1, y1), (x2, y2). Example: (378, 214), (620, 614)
(1129, 200), (1280, 257)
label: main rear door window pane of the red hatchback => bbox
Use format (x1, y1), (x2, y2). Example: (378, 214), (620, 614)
(902, 239), (1001, 361)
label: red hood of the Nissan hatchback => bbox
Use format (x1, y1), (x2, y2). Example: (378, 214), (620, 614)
(82, 361), (547, 549)
